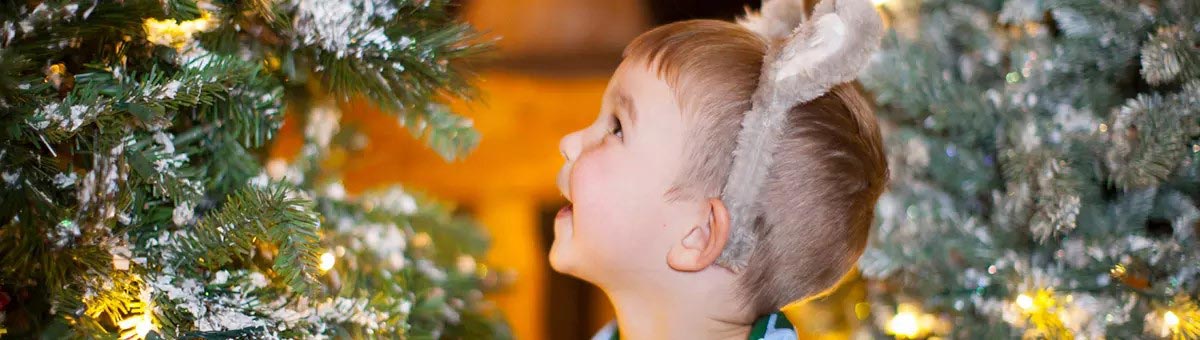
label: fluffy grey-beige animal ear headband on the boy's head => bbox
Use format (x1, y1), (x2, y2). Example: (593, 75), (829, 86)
(716, 0), (883, 272)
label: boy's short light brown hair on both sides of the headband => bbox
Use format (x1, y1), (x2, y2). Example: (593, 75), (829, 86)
(625, 20), (888, 314)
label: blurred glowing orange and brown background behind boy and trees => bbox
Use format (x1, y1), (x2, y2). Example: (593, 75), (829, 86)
(272, 0), (864, 340)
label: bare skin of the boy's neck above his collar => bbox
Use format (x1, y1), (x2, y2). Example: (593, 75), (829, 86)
(605, 273), (756, 340)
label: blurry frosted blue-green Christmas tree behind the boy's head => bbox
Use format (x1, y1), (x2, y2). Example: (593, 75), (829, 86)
(859, 0), (1200, 339)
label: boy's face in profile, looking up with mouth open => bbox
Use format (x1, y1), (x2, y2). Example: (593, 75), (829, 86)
(550, 60), (703, 286)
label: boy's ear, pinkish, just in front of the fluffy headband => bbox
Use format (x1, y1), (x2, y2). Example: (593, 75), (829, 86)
(667, 198), (730, 272)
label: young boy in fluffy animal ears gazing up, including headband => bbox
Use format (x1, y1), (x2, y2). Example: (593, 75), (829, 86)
(550, 0), (888, 339)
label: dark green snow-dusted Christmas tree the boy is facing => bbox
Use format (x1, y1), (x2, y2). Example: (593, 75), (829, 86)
(0, 0), (506, 339)
